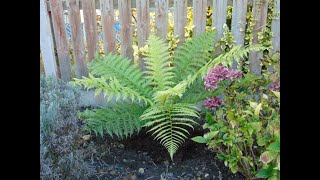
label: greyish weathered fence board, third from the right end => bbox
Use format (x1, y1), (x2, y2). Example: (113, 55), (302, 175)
(231, 0), (248, 69)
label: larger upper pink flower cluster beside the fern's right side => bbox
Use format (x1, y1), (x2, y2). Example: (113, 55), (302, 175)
(204, 65), (242, 91)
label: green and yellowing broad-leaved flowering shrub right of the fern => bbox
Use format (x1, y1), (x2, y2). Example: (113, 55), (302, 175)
(192, 60), (280, 179)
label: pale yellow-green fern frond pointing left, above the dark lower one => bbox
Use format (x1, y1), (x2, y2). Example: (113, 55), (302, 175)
(73, 74), (153, 105)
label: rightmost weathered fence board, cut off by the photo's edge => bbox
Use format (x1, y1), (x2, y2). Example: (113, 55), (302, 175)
(271, 0), (280, 54)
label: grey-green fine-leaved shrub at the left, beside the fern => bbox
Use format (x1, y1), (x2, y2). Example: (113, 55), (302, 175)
(40, 76), (94, 179)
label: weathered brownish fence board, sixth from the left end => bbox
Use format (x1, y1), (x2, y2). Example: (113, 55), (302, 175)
(118, 0), (133, 59)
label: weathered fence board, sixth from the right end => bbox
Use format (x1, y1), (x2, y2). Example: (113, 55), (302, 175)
(174, 0), (188, 43)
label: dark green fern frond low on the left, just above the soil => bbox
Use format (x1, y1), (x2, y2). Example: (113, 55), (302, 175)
(80, 103), (146, 138)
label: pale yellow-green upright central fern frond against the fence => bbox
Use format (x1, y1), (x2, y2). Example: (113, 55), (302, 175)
(144, 34), (174, 92)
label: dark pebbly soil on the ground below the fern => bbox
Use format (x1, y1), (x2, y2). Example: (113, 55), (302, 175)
(82, 126), (245, 180)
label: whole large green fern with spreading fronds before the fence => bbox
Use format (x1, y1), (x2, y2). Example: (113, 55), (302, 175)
(74, 31), (262, 160)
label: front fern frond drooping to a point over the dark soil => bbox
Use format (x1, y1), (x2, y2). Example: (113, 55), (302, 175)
(141, 103), (199, 160)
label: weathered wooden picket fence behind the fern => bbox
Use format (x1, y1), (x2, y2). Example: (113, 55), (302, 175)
(40, 0), (280, 81)
